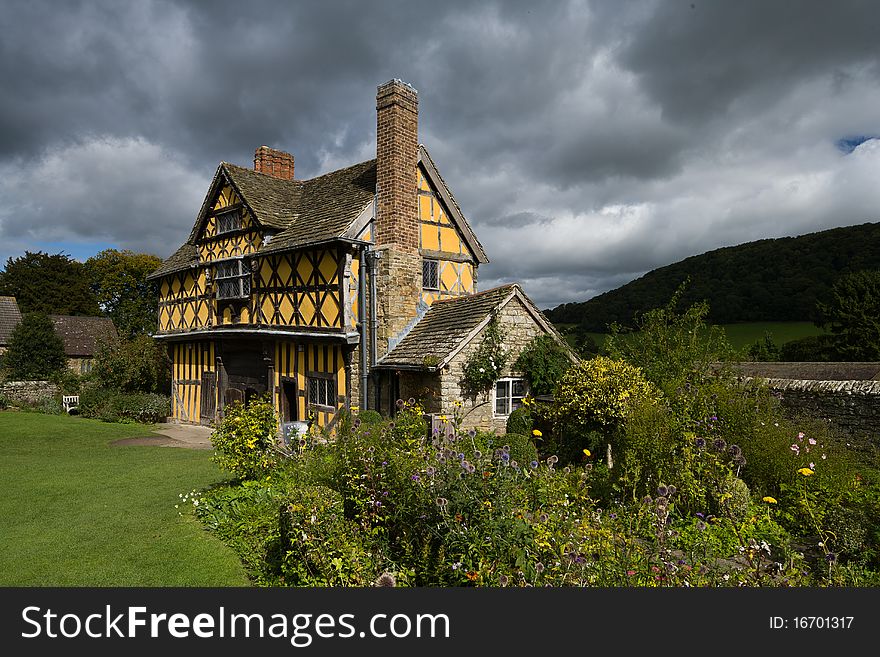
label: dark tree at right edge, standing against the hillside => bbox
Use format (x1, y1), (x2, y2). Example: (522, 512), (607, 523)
(816, 270), (880, 361)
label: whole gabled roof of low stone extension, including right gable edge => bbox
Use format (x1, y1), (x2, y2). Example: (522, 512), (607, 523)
(377, 283), (564, 370)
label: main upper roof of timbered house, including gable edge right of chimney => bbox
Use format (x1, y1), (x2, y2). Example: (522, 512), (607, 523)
(147, 146), (489, 279)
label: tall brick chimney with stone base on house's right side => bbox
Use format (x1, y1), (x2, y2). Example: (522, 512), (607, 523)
(374, 80), (422, 357)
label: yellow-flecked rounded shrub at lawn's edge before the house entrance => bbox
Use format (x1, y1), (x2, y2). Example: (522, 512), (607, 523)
(211, 398), (279, 479)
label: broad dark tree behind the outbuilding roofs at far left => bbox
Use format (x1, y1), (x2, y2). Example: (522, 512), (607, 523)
(0, 251), (100, 315)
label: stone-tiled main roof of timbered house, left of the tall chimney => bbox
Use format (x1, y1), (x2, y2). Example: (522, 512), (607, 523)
(148, 160), (376, 279)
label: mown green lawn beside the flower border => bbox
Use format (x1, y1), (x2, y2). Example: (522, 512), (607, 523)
(0, 411), (250, 587)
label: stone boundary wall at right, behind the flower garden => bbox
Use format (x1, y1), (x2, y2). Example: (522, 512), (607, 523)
(745, 377), (880, 438)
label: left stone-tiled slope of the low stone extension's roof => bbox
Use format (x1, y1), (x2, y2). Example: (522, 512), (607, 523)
(378, 284), (519, 369)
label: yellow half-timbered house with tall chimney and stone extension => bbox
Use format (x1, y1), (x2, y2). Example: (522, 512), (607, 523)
(151, 80), (572, 430)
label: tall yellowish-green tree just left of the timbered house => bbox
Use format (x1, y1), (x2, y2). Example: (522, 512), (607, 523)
(85, 249), (162, 338)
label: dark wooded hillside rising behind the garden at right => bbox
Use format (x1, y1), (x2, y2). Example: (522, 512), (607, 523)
(544, 223), (880, 333)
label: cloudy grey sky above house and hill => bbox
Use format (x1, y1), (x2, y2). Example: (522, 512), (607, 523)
(0, 0), (880, 308)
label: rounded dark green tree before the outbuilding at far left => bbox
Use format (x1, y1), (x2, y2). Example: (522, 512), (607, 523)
(3, 313), (67, 381)
